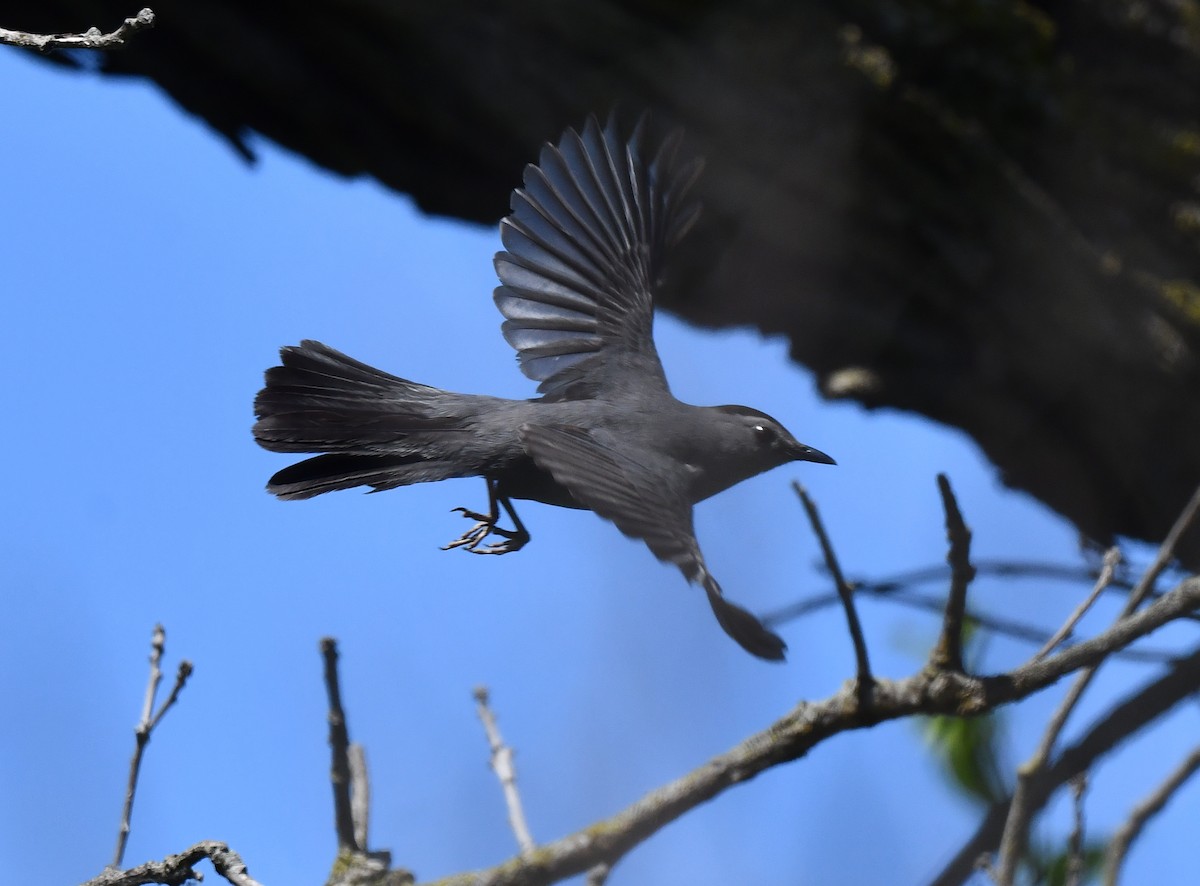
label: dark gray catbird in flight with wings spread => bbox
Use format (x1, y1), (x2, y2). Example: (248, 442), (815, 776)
(254, 118), (834, 660)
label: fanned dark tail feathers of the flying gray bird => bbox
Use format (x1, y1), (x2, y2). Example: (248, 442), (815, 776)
(253, 341), (466, 498)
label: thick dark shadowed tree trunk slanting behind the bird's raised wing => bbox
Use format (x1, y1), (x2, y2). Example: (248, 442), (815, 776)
(11, 0), (1200, 567)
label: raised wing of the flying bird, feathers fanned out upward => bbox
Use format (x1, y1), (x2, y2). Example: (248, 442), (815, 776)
(496, 118), (700, 400)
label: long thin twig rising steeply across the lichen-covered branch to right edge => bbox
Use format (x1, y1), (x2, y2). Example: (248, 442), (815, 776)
(996, 486), (1200, 886)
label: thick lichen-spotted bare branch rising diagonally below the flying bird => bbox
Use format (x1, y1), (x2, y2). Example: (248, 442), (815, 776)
(427, 579), (1200, 886)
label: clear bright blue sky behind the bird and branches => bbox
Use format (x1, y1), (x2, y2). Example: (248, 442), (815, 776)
(0, 43), (1200, 886)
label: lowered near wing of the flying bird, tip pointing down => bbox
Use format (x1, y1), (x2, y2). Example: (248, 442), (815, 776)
(521, 425), (787, 660)
